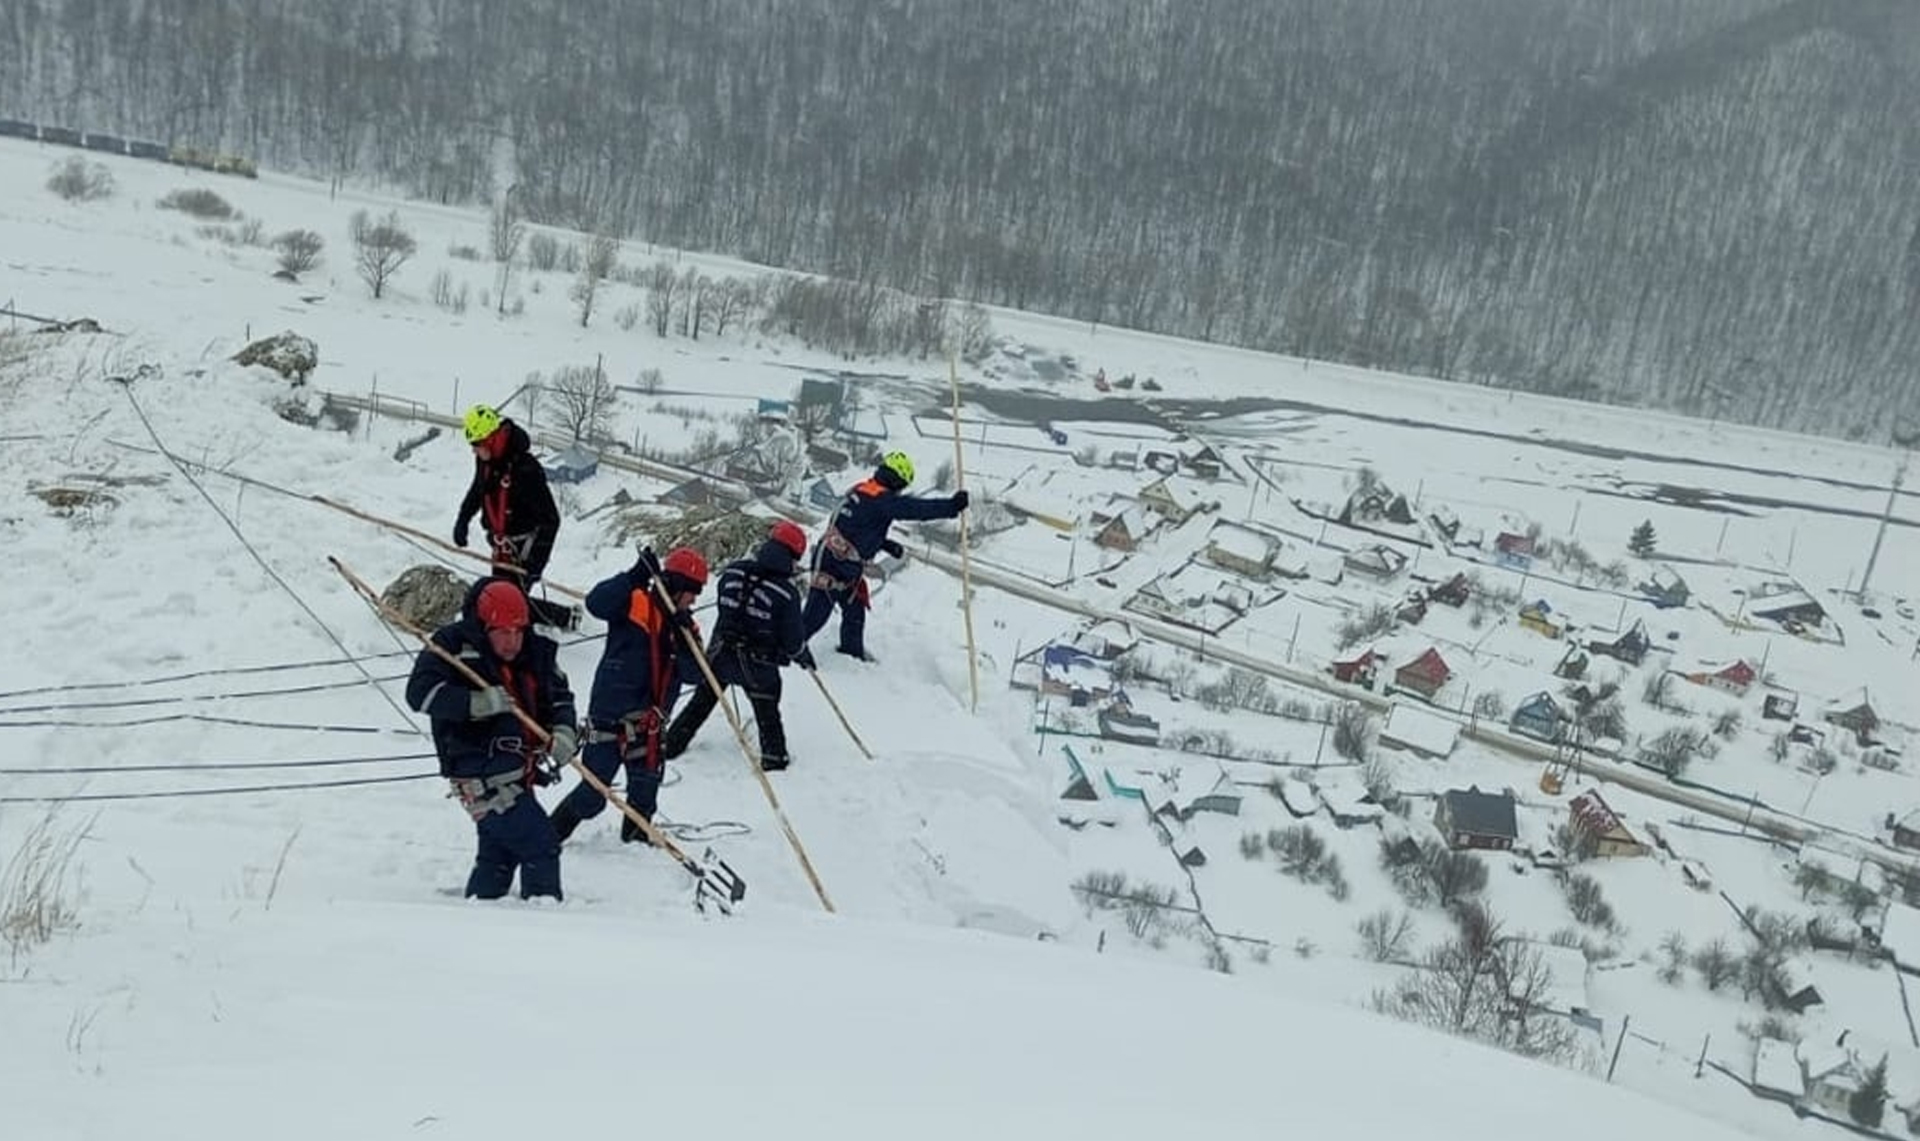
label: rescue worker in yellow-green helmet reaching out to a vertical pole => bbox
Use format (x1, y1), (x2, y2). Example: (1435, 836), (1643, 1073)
(803, 451), (968, 661)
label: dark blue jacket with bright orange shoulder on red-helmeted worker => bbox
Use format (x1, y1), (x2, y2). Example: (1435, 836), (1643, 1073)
(588, 567), (699, 726)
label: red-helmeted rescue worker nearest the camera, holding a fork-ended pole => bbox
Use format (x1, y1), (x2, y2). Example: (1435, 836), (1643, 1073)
(407, 578), (578, 899)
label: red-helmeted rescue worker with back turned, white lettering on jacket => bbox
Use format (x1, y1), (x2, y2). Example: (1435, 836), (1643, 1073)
(660, 519), (814, 772)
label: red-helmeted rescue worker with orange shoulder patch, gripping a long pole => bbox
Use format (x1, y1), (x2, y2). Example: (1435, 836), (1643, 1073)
(553, 547), (707, 841)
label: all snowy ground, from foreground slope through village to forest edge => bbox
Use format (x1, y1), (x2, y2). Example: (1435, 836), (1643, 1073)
(0, 140), (1920, 1137)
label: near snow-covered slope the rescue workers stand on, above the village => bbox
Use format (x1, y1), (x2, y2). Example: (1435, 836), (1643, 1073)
(0, 140), (1904, 1141)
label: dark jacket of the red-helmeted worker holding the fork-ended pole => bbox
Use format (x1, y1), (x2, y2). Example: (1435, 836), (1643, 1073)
(407, 578), (576, 778)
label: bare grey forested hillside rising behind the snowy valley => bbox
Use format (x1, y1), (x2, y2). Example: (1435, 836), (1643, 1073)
(0, 0), (1920, 440)
